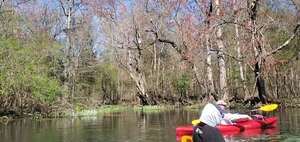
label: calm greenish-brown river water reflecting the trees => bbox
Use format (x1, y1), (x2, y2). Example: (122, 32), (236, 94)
(0, 109), (300, 142)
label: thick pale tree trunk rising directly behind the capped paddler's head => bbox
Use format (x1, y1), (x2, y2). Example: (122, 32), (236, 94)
(215, 0), (229, 101)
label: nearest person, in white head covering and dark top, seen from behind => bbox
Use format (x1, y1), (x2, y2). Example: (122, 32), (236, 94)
(193, 103), (225, 142)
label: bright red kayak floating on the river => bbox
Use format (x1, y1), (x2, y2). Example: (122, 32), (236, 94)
(176, 117), (277, 141)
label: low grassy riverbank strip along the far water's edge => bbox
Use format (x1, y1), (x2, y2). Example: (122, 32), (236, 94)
(0, 99), (300, 124)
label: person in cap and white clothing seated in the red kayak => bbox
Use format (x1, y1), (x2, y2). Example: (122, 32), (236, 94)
(216, 100), (252, 125)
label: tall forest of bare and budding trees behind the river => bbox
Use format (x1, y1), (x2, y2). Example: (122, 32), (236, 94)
(0, 0), (300, 115)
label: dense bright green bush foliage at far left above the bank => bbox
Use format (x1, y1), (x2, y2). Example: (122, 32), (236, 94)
(0, 35), (63, 102)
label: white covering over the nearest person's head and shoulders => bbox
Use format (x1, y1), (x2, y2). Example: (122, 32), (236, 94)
(200, 103), (222, 127)
